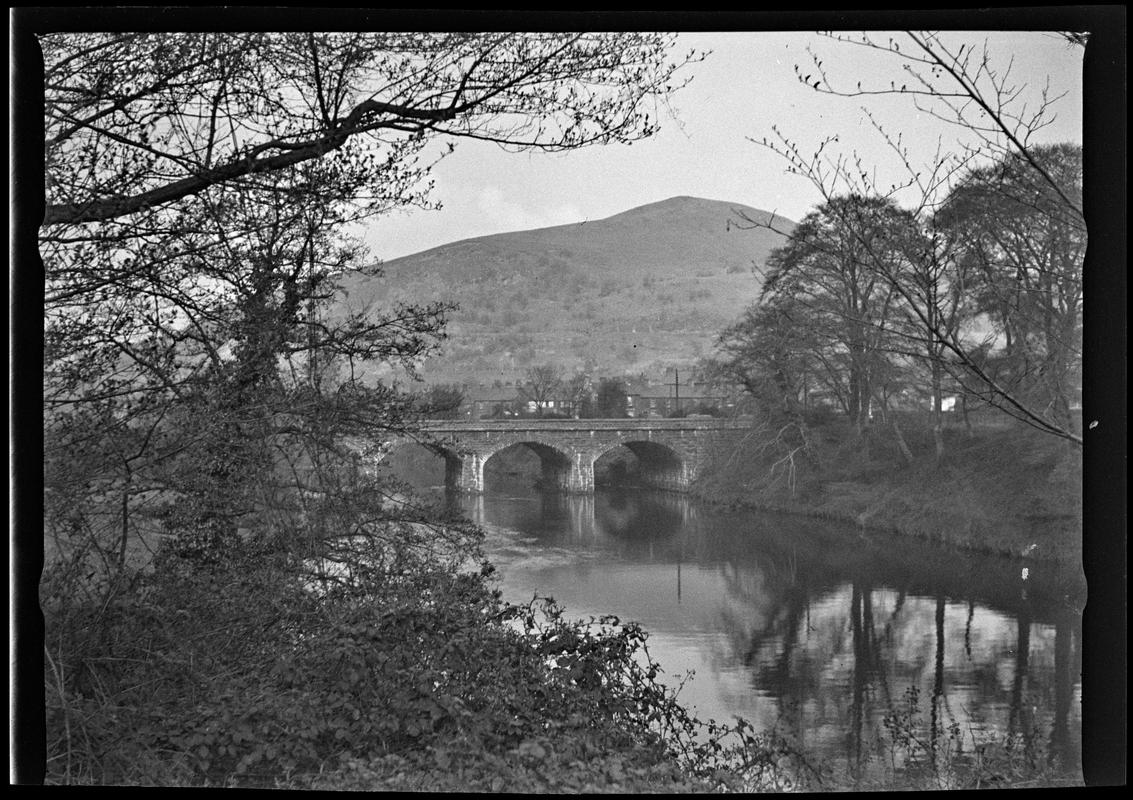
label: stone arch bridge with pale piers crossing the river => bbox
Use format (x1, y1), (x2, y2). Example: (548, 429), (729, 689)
(380, 418), (751, 494)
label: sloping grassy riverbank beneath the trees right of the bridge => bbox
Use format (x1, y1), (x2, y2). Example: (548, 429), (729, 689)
(693, 422), (1082, 572)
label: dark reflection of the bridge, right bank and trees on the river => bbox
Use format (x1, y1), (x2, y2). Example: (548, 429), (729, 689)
(469, 484), (1081, 769)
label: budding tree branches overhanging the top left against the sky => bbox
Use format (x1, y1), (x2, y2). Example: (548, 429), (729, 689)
(41, 32), (697, 225)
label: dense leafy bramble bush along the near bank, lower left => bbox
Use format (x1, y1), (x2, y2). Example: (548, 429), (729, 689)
(44, 514), (806, 791)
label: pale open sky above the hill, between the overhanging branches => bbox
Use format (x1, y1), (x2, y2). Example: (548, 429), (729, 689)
(364, 31), (1083, 261)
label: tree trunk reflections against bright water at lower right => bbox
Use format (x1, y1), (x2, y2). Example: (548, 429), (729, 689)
(721, 546), (1080, 773)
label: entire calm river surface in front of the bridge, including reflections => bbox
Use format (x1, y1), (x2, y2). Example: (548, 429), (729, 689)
(450, 482), (1082, 768)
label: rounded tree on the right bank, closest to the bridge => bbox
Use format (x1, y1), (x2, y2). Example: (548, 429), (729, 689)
(717, 195), (917, 471)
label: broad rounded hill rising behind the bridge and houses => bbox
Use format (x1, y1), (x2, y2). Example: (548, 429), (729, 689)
(344, 192), (793, 383)
